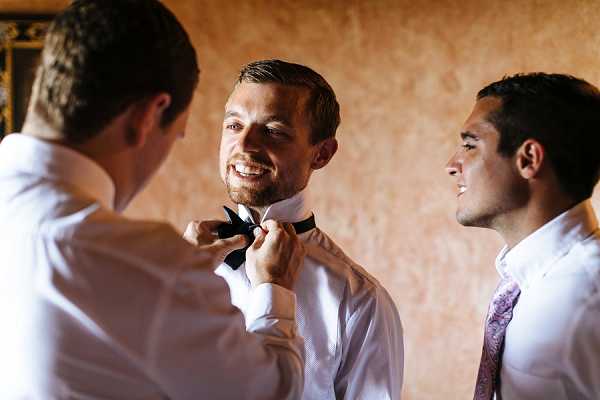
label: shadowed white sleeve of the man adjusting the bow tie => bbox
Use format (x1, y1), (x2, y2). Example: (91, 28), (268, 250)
(63, 223), (304, 400)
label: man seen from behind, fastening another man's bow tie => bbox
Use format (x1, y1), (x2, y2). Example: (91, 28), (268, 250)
(0, 0), (305, 400)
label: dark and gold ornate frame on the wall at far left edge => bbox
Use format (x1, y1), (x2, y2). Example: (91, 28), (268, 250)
(0, 14), (53, 139)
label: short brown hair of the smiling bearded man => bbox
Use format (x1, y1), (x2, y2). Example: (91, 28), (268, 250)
(237, 60), (340, 144)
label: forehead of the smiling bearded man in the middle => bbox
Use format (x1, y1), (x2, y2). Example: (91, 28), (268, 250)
(225, 82), (309, 117)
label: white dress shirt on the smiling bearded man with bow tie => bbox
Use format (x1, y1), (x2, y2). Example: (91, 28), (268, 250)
(216, 192), (404, 400)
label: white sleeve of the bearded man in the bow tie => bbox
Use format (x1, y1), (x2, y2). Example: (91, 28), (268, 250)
(335, 287), (404, 400)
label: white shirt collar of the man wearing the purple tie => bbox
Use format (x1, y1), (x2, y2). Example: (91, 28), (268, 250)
(496, 199), (598, 289)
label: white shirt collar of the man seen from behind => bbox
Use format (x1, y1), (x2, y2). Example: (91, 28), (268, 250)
(0, 134), (115, 210)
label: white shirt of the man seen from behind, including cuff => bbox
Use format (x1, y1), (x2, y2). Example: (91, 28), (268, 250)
(0, 134), (304, 400)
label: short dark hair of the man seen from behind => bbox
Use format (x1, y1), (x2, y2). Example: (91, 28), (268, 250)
(32, 0), (199, 143)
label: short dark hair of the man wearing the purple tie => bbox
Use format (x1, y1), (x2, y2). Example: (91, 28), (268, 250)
(477, 72), (600, 201)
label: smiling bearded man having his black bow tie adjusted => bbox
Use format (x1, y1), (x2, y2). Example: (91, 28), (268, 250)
(187, 60), (404, 400)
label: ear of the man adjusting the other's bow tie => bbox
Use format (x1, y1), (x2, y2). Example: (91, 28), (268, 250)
(127, 93), (171, 147)
